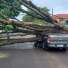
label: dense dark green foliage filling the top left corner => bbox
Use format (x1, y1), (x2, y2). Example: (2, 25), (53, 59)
(0, 0), (21, 18)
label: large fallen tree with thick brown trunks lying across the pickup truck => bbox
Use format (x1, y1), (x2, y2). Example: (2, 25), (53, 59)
(0, 0), (68, 43)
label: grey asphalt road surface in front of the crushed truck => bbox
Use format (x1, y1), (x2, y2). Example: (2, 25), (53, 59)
(0, 44), (68, 68)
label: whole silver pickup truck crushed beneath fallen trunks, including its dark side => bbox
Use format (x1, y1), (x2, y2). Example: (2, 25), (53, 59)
(35, 33), (68, 51)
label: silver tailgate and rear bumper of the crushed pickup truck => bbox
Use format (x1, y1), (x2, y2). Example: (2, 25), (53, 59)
(47, 33), (68, 50)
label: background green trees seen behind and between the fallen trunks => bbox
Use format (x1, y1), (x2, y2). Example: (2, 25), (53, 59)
(23, 7), (49, 24)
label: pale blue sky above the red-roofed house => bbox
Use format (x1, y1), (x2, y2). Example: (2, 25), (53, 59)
(32, 0), (68, 14)
